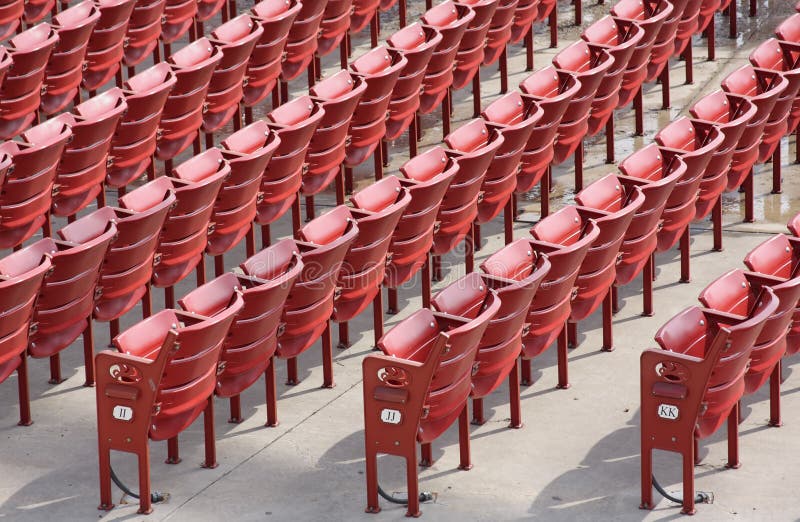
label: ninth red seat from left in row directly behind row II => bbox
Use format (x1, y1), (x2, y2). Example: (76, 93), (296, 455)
(384, 22), (442, 152)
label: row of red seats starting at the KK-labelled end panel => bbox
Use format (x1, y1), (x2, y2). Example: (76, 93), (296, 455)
(641, 210), (800, 514)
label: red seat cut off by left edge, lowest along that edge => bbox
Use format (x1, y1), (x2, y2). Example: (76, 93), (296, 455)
(0, 245), (52, 426)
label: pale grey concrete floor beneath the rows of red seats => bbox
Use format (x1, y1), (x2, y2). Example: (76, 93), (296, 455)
(0, 0), (800, 521)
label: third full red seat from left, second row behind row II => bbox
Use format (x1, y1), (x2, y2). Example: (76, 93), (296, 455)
(106, 62), (177, 188)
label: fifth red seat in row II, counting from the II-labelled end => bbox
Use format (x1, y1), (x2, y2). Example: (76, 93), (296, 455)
(331, 176), (411, 348)
